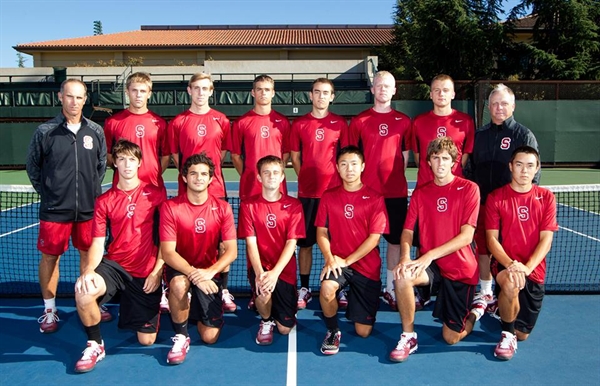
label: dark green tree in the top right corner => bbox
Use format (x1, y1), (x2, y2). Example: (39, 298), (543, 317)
(508, 0), (600, 80)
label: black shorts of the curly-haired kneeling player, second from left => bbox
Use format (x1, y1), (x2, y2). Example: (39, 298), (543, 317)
(165, 265), (224, 328)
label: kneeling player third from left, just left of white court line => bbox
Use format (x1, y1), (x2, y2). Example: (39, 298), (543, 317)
(238, 155), (306, 346)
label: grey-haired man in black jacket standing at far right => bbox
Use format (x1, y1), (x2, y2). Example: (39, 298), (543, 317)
(464, 84), (540, 312)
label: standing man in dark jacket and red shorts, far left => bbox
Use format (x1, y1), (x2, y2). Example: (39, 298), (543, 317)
(27, 79), (106, 333)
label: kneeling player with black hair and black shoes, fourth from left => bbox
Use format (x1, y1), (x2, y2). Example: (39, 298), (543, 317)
(315, 146), (389, 355)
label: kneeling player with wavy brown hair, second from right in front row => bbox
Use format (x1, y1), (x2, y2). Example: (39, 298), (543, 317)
(390, 137), (479, 362)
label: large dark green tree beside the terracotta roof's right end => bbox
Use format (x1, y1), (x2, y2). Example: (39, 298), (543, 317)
(382, 0), (506, 81)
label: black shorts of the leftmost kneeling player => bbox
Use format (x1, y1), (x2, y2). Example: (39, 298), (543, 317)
(95, 259), (162, 334)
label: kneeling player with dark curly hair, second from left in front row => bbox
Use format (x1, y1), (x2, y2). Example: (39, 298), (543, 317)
(160, 153), (237, 365)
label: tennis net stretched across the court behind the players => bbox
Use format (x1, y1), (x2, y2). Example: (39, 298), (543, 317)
(0, 184), (600, 297)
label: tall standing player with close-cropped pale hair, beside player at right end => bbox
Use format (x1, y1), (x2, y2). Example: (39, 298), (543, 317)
(343, 71), (410, 310)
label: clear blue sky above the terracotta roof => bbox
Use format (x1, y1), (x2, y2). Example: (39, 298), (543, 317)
(0, 0), (519, 68)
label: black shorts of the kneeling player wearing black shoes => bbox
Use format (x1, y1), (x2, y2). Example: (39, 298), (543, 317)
(325, 267), (381, 326)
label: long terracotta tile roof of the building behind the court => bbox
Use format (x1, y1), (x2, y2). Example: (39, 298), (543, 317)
(15, 25), (393, 50)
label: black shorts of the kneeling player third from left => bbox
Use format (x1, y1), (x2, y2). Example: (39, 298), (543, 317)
(248, 268), (298, 328)
